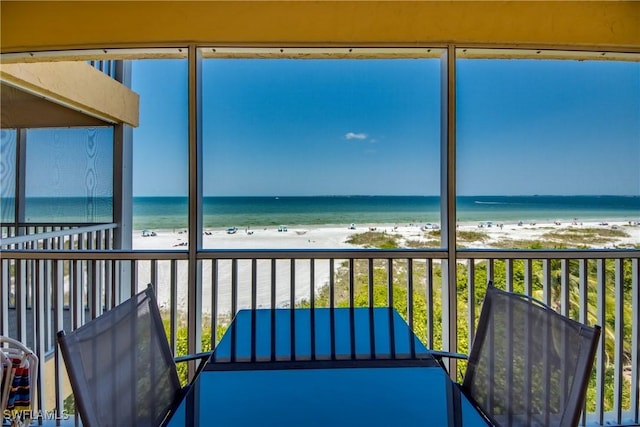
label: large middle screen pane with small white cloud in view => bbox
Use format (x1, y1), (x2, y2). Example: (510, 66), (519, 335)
(202, 59), (440, 248)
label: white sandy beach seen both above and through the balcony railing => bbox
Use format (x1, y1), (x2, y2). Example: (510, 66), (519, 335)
(133, 220), (640, 315)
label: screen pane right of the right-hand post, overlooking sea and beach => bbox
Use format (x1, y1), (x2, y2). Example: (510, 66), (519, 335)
(457, 59), (640, 248)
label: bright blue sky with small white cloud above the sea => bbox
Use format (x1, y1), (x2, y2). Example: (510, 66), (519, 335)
(124, 55), (640, 196)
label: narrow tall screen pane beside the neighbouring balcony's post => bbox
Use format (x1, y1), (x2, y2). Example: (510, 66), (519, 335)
(131, 59), (189, 249)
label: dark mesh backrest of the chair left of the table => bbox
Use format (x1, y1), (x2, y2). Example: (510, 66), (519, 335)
(58, 286), (181, 427)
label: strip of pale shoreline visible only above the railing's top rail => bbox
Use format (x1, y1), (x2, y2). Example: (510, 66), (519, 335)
(133, 218), (640, 249)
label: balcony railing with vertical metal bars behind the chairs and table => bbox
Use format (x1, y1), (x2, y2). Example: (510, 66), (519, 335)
(0, 232), (640, 425)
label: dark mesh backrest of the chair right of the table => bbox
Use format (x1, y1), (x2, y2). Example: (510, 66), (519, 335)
(462, 283), (600, 426)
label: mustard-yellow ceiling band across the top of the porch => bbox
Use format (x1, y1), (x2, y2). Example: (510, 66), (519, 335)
(0, 0), (640, 53)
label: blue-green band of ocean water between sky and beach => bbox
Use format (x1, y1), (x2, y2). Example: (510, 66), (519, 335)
(0, 196), (640, 230)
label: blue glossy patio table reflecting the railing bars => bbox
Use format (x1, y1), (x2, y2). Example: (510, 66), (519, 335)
(168, 308), (488, 427)
